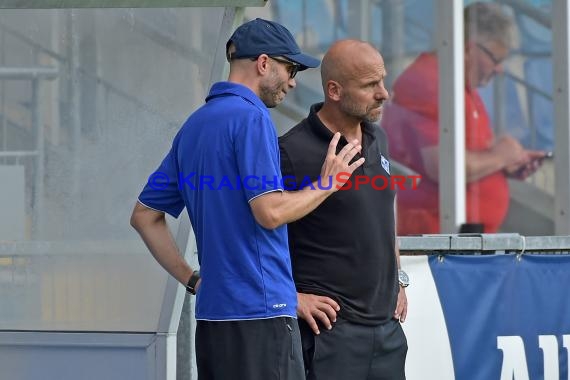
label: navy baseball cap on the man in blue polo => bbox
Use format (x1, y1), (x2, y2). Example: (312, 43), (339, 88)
(226, 18), (321, 70)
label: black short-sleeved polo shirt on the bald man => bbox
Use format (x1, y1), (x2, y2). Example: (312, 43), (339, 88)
(279, 103), (399, 325)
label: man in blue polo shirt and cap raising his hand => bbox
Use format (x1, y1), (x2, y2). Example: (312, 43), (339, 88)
(131, 19), (364, 380)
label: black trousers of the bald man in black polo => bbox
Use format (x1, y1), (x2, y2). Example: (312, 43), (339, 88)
(299, 318), (408, 380)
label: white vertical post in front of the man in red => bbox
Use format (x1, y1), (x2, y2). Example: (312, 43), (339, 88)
(436, 0), (466, 233)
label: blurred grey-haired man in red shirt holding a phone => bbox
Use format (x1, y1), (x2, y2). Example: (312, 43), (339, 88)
(381, 3), (545, 235)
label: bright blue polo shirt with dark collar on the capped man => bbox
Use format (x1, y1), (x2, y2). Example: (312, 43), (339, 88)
(139, 82), (297, 320)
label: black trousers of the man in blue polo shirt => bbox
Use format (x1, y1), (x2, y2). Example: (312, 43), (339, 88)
(196, 317), (305, 380)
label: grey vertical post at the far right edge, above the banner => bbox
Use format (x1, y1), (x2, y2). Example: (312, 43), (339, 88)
(552, 0), (570, 235)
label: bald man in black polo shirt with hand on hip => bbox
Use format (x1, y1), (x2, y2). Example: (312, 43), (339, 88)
(279, 40), (408, 380)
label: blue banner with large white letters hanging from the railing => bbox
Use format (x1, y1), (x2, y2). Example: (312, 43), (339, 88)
(428, 255), (570, 380)
